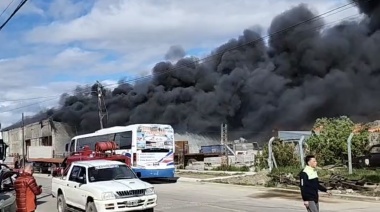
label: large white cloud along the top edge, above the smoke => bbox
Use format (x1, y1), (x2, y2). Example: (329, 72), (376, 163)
(28, 0), (358, 52)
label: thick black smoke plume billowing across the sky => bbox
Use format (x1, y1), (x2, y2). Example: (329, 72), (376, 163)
(11, 0), (380, 141)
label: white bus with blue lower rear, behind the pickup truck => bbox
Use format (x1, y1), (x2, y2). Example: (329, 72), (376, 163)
(66, 124), (176, 180)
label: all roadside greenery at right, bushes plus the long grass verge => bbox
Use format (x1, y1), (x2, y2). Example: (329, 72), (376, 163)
(181, 116), (380, 196)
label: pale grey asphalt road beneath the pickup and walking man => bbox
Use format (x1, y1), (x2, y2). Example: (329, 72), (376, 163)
(36, 177), (380, 212)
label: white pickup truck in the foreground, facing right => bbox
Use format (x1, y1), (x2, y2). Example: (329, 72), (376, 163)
(51, 160), (157, 212)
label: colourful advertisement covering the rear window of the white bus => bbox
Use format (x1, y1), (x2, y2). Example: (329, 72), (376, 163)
(137, 125), (174, 150)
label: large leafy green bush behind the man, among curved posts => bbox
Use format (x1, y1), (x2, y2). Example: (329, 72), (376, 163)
(306, 116), (369, 165)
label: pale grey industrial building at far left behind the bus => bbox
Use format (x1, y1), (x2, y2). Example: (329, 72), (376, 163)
(1, 119), (75, 157)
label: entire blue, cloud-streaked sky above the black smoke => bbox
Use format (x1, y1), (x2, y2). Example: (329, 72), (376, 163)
(0, 0), (357, 127)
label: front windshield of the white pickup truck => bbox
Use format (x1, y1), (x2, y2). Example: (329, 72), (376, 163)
(88, 165), (137, 183)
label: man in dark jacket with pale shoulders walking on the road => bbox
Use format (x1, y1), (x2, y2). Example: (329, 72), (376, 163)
(300, 155), (331, 212)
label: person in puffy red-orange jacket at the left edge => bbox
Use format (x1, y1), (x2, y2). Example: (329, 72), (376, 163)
(14, 164), (42, 212)
